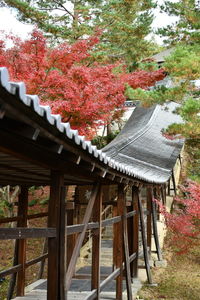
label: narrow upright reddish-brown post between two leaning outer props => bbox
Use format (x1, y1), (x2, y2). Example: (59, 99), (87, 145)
(131, 186), (139, 278)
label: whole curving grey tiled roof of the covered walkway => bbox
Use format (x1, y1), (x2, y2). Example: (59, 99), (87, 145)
(0, 68), (183, 184)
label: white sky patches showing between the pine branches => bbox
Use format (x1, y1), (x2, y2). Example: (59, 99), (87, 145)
(0, 0), (177, 44)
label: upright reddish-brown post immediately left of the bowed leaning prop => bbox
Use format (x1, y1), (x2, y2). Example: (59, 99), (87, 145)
(113, 184), (124, 300)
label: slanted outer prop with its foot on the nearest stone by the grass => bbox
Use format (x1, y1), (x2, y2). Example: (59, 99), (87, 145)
(138, 190), (152, 284)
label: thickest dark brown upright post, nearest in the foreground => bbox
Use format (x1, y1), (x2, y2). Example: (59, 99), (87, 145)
(47, 171), (66, 300)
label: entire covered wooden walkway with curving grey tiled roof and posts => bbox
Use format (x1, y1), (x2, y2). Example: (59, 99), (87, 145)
(0, 68), (183, 300)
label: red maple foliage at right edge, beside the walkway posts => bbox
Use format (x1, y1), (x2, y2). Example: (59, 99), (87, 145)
(155, 181), (200, 254)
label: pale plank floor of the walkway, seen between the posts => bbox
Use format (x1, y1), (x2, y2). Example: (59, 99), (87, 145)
(14, 227), (143, 300)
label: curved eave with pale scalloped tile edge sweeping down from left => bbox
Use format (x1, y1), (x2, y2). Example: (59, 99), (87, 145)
(0, 68), (183, 184)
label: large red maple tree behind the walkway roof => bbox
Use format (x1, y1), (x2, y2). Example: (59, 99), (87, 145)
(0, 30), (165, 137)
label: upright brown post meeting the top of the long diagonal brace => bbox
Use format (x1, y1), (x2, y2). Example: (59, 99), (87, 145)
(91, 187), (102, 299)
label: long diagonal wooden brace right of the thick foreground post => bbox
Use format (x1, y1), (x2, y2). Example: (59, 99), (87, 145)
(66, 183), (99, 291)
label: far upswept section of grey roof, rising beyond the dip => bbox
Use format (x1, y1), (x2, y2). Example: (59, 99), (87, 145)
(102, 102), (183, 183)
